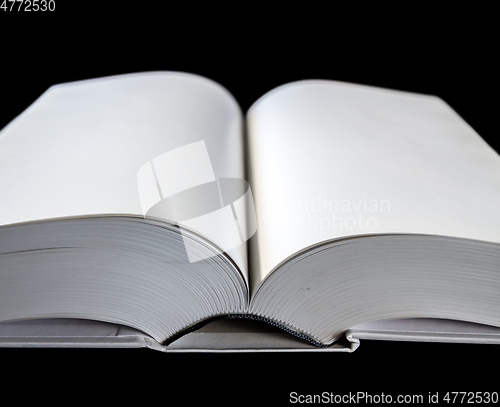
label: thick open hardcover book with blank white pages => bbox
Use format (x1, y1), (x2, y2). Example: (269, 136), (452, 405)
(0, 72), (500, 350)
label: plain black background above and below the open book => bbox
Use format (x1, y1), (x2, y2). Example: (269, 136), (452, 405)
(0, 6), (500, 404)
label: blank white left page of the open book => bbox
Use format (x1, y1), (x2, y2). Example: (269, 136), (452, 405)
(0, 72), (247, 276)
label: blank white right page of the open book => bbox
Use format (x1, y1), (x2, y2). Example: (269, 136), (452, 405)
(247, 80), (500, 289)
